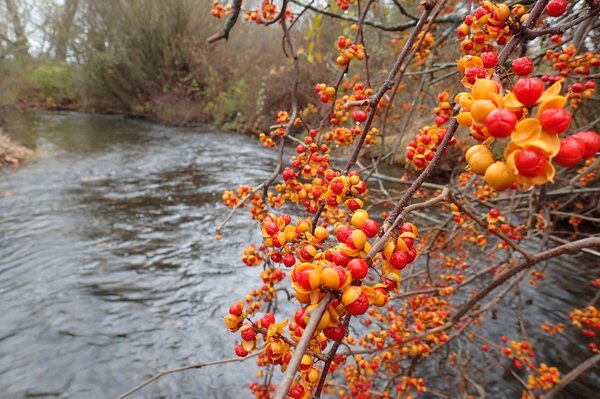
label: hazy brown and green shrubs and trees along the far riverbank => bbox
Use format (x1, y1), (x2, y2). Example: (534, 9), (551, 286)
(0, 0), (335, 130)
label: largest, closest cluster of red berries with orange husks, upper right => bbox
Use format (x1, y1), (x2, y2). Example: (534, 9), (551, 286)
(457, 62), (598, 190)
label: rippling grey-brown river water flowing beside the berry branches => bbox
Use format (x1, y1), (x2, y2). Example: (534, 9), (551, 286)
(0, 112), (600, 399)
